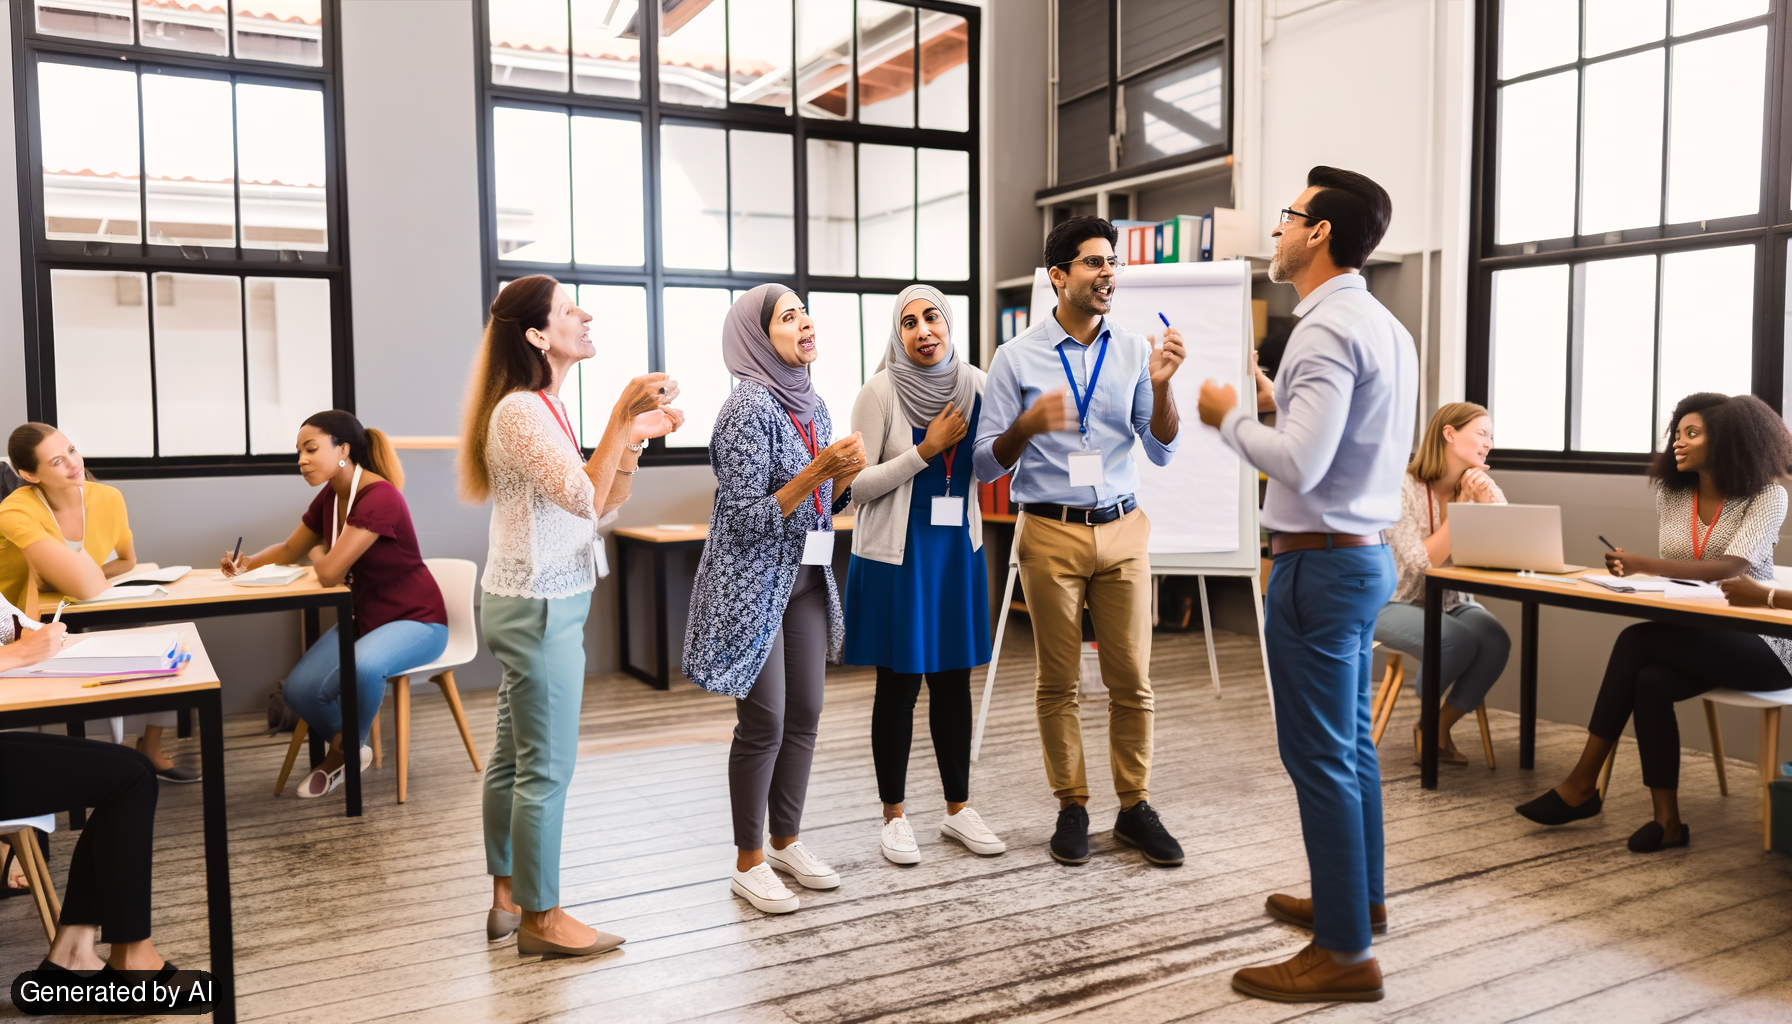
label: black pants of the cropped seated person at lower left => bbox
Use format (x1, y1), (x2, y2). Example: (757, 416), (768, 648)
(0, 732), (159, 942)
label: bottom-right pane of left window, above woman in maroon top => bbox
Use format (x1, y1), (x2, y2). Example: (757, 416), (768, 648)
(243, 278), (335, 456)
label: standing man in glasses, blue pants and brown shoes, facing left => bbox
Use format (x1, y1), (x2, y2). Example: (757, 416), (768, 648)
(1197, 167), (1419, 1002)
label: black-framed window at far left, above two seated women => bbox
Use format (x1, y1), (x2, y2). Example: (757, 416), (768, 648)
(11, 0), (353, 475)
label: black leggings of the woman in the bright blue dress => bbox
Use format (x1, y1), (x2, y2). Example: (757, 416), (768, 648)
(871, 665), (971, 803)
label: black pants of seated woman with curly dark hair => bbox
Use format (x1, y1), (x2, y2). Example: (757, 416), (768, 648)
(1586, 622), (1792, 789)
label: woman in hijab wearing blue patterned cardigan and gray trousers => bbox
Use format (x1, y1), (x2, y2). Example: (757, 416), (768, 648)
(685, 285), (866, 915)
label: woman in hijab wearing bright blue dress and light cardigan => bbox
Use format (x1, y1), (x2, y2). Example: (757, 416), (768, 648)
(844, 285), (1007, 864)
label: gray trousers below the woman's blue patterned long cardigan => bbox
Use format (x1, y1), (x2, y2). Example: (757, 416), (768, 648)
(728, 565), (828, 850)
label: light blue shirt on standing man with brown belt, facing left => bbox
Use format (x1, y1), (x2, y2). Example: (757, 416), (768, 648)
(1220, 274), (1419, 534)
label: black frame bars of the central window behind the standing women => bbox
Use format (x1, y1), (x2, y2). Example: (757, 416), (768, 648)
(473, 0), (982, 466)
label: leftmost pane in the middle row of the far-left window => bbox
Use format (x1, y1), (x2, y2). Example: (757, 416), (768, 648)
(38, 61), (142, 242)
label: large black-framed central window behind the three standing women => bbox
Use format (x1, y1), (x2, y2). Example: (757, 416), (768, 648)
(477, 0), (978, 461)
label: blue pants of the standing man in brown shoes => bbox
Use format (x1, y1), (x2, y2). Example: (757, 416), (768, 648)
(1263, 545), (1394, 952)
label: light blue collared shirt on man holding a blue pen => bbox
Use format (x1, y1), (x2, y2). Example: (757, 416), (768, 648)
(973, 308), (1181, 508)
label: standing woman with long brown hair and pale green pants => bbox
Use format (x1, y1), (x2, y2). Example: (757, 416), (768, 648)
(461, 274), (685, 956)
